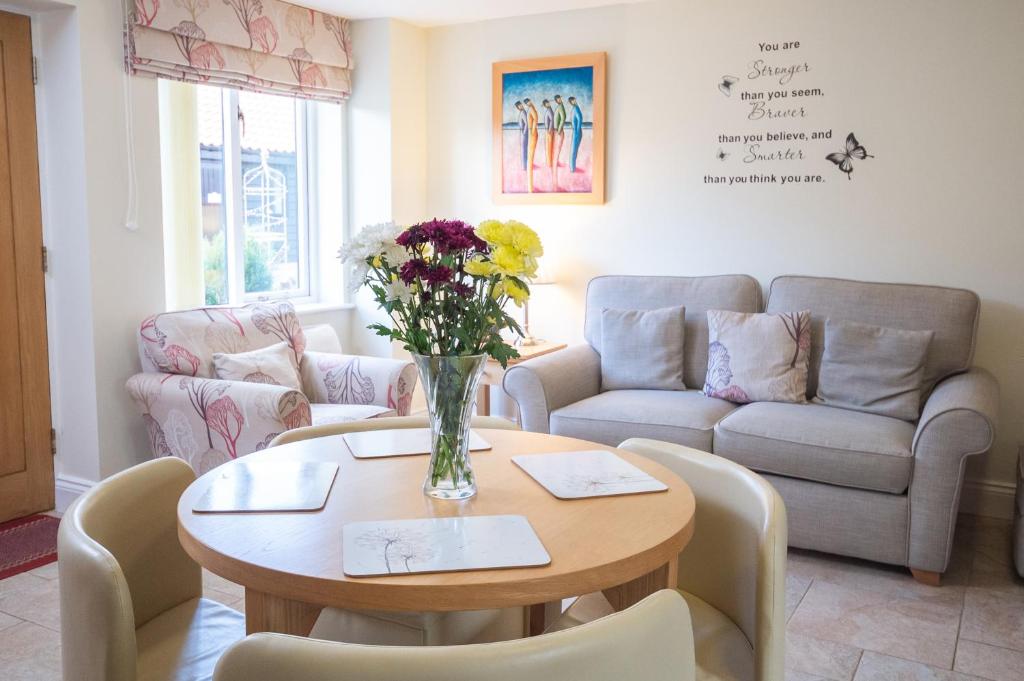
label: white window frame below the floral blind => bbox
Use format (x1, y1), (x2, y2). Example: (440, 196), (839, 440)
(221, 88), (319, 305)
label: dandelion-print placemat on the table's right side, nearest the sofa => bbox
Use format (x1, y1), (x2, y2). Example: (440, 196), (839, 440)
(512, 450), (669, 499)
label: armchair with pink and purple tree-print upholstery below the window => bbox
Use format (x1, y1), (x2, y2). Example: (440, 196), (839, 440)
(126, 302), (417, 473)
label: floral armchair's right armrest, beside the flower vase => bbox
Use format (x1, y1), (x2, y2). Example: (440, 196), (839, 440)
(300, 352), (419, 416)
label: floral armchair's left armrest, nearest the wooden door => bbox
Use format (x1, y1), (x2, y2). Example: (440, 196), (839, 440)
(125, 373), (311, 473)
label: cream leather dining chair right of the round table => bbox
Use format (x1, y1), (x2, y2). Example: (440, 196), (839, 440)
(548, 438), (787, 681)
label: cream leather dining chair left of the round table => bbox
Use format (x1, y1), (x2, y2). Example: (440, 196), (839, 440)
(57, 457), (246, 681)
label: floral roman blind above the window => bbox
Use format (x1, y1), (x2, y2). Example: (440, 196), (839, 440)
(125, 0), (352, 101)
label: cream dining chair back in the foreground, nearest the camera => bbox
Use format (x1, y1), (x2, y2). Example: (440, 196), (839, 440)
(213, 590), (695, 681)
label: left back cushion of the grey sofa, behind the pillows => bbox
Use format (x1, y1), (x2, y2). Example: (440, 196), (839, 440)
(584, 274), (761, 390)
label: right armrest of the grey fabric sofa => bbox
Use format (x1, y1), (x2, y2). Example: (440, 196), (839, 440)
(908, 369), (999, 572)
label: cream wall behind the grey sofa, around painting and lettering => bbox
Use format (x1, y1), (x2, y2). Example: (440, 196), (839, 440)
(425, 0), (1024, 499)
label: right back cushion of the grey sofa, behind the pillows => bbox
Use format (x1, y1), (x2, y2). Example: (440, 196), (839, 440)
(770, 276), (981, 397)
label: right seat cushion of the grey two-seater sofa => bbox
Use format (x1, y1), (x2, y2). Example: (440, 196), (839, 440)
(715, 402), (914, 494)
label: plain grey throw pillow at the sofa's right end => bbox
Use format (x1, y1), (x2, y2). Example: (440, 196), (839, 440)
(814, 320), (935, 421)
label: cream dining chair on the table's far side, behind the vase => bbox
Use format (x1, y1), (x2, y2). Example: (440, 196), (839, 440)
(270, 416), (526, 645)
